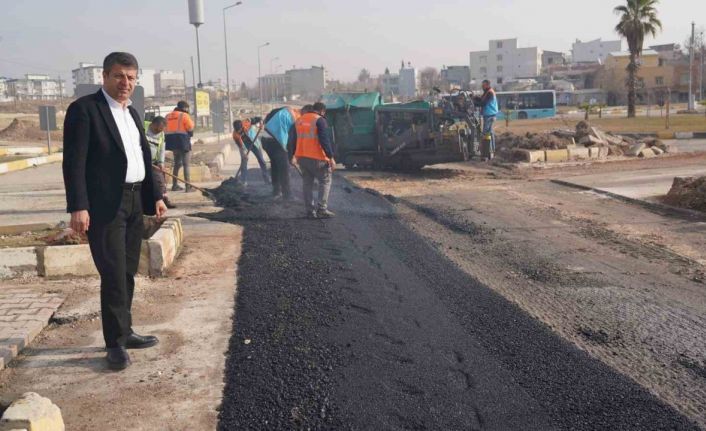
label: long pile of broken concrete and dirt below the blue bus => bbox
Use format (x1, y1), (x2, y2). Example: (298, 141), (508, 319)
(496, 121), (674, 160)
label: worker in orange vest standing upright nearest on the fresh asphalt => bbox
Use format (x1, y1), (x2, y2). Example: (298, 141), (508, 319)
(288, 102), (336, 218)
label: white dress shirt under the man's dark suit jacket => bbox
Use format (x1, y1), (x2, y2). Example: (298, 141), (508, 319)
(102, 89), (145, 183)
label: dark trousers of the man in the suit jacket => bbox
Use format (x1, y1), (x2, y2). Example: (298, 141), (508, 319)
(88, 189), (144, 347)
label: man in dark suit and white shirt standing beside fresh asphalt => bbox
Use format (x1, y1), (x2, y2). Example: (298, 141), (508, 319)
(63, 52), (167, 370)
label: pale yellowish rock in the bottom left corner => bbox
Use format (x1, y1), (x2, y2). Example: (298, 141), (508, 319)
(0, 392), (65, 431)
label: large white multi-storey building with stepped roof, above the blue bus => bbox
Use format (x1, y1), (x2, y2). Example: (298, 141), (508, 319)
(470, 39), (542, 87)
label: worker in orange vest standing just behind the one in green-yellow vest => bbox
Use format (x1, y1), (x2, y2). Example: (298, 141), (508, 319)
(164, 100), (195, 193)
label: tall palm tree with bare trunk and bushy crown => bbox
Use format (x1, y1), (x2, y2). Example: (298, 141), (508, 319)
(613, 0), (662, 118)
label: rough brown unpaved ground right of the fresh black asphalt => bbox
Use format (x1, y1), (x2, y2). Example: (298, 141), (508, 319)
(345, 155), (706, 427)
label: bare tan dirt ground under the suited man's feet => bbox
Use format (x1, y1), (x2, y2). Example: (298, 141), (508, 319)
(0, 208), (242, 430)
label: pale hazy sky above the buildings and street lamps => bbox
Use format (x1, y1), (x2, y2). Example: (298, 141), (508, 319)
(0, 0), (706, 88)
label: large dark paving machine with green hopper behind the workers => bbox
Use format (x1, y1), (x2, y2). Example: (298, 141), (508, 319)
(323, 93), (480, 170)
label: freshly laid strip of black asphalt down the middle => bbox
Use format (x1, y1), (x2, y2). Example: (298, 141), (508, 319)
(210, 175), (696, 430)
